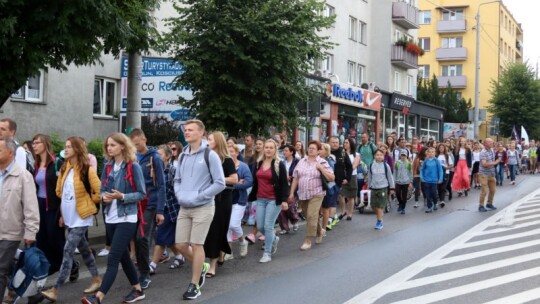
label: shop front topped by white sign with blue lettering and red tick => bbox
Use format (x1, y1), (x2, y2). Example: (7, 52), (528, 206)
(321, 82), (382, 142)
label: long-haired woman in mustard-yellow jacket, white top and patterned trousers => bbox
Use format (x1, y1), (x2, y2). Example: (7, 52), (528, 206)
(43, 136), (101, 302)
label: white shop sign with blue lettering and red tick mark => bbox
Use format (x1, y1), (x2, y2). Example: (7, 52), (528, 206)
(332, 83), (382, 111)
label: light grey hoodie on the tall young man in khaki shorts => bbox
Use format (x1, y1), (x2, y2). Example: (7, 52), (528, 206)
(174, 142), (225, 208)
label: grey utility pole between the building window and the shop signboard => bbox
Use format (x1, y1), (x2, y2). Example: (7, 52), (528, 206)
(126, 53), (142, 130)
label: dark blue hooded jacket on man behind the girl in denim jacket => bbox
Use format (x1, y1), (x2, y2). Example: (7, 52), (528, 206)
(139, 147), (166, 214)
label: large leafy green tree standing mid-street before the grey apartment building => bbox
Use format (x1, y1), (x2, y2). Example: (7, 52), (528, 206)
(165, 0), (334, 135)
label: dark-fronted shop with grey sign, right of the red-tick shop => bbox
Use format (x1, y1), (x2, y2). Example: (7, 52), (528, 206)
(379, 91), (444, 141)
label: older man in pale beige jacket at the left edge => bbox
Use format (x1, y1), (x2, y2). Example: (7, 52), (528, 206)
(0, 137), (39, 301)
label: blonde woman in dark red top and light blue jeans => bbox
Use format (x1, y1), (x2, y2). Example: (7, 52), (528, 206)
(248, 139), (289, 263)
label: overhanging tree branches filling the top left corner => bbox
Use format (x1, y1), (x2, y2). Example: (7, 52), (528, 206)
(0, 0), (159, 107)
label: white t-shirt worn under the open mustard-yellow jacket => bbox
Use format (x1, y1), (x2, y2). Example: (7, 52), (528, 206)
(61, 169), (94, 228)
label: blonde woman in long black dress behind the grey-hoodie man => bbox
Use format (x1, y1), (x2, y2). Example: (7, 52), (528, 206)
(204, 131), (238, 278)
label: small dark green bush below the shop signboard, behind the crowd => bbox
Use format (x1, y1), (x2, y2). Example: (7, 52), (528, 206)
(141, 116), (181, 147)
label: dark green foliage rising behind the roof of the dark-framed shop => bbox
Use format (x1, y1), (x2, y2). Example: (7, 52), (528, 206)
(417, 75), (471, 123)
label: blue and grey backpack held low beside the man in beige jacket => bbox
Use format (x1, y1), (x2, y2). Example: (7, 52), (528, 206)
(9, 245), (50, 297)
